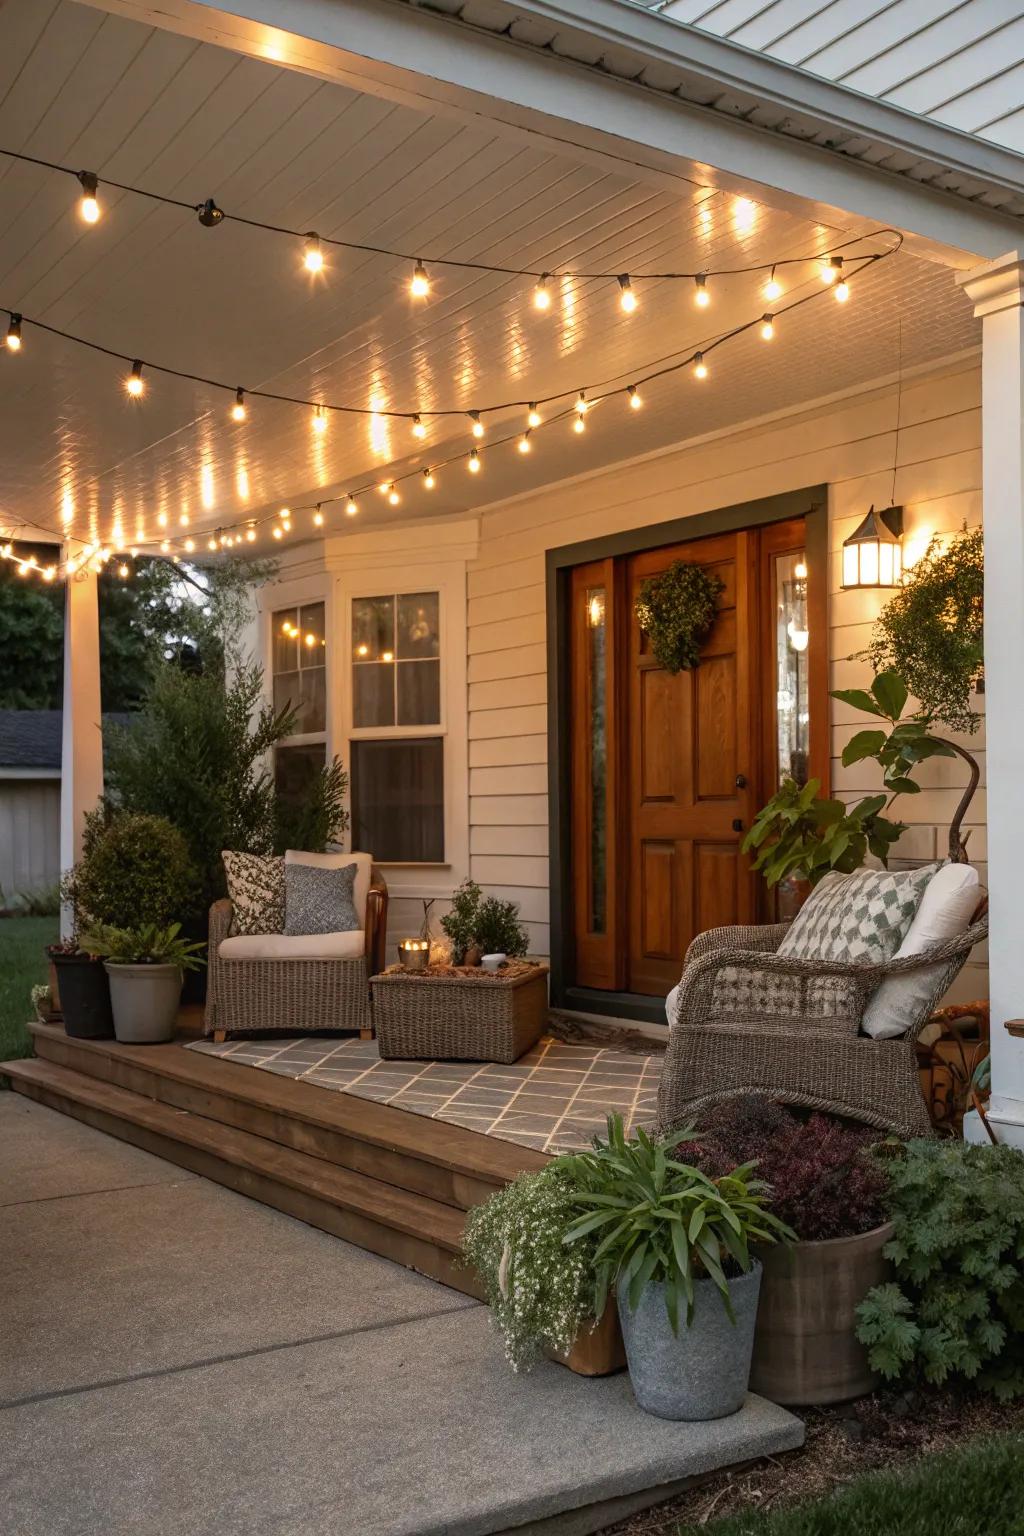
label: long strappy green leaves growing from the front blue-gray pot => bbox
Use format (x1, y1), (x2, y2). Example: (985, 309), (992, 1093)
(559, 1115), (794, 1333)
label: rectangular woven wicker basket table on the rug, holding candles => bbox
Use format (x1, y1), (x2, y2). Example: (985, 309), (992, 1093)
(370, 965), (548, 1061)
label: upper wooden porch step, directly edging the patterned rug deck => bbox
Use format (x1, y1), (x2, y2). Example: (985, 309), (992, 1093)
(31, 1025), (548, 1210)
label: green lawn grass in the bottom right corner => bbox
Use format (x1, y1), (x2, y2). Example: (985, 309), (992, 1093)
(676, 1435), (1024, 1536)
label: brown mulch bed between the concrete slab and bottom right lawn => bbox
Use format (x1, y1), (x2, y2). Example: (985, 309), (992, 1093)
(602, 1389), (1024, 1536)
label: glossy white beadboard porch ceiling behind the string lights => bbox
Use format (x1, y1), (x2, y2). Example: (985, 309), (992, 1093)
(0, 0), (978, 562)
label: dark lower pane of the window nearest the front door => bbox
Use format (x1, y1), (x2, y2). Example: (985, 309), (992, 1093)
(350, 737), (444, 863)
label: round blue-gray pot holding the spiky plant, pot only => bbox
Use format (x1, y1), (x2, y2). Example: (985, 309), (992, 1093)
(619, 1264), (761, 1421)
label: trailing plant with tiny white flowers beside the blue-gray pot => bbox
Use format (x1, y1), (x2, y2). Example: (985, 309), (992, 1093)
(464, 1163), (597, 1370)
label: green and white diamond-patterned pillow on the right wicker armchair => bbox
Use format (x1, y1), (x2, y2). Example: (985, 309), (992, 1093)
(778, 865), (938, 965)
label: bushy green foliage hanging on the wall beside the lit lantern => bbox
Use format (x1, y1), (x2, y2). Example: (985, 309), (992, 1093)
(860, 528), (984, 734)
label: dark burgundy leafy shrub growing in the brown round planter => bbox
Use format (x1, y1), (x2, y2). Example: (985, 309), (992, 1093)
(685, 1094), (887, 1243)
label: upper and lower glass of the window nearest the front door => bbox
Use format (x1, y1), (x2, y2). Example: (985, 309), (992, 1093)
(350, 591), (445, 863)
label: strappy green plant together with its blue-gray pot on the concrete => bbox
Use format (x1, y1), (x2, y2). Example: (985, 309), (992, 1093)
(565, 1117), (792, 1421)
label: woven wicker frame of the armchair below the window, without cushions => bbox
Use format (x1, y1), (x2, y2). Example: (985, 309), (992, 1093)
(203, 869), (387, 1040)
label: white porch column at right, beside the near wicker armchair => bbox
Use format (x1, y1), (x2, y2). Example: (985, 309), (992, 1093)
(958, 250), (1024, 1146)
